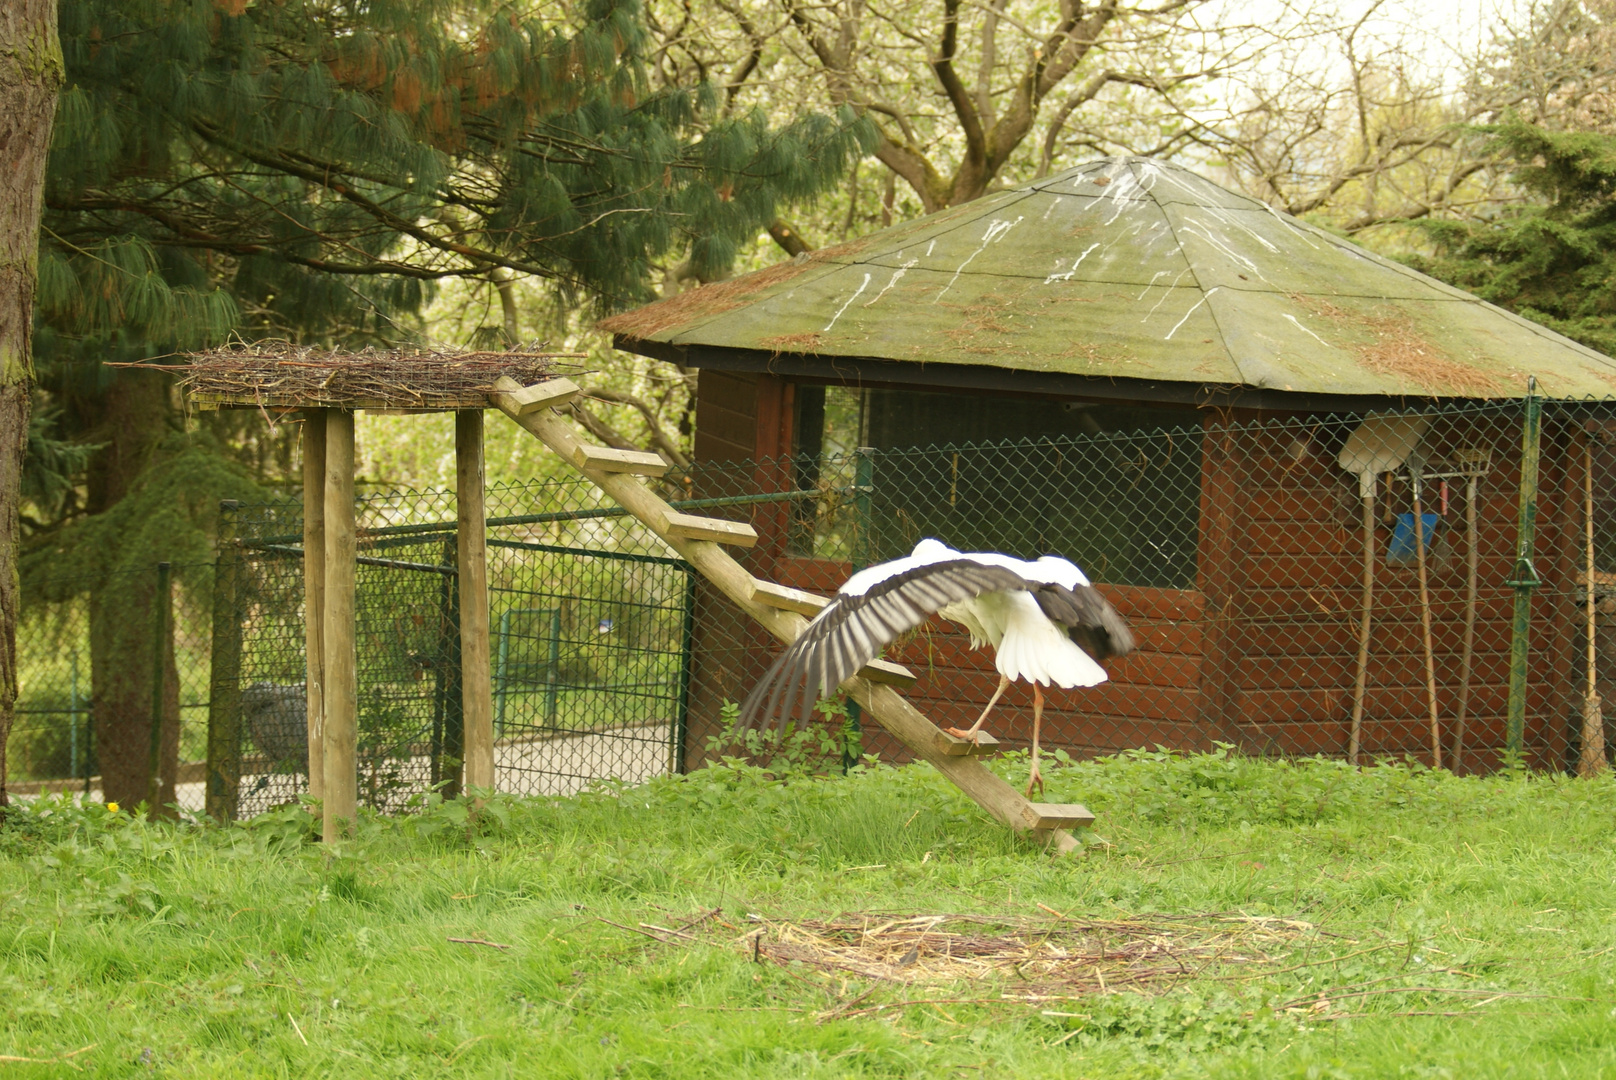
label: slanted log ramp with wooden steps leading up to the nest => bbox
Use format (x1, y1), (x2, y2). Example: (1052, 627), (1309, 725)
(490, 378), (1094, 852)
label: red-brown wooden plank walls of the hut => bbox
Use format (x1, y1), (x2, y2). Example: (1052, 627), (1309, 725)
(687, 370), (1580, 770)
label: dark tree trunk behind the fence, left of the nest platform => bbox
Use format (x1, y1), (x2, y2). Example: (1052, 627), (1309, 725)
(86, 370), (179, 807)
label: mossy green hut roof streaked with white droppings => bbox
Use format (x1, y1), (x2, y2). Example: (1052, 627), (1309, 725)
(601, 157), (1616, 398)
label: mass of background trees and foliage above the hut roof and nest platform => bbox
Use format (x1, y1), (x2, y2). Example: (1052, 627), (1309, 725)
(15, 0), (1616, 801)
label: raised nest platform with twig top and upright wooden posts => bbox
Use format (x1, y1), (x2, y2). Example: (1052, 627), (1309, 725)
(181, 346), (572, 841)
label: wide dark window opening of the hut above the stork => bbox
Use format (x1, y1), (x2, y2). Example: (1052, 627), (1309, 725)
(795, 388), (1201, 589)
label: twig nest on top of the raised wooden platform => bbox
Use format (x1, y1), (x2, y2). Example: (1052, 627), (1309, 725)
(179, 343), (580, 411)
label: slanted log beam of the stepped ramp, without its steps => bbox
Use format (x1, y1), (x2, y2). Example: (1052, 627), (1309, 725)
(491, 378), (1079, 852)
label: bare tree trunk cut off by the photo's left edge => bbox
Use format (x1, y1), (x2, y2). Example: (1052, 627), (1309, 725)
(0, 0), (63, 808)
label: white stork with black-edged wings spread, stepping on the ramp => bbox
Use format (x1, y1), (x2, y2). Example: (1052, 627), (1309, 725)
(740, 538), (1134, 795)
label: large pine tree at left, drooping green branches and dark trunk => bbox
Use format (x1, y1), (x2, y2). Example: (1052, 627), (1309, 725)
(34, 0), (866, 802)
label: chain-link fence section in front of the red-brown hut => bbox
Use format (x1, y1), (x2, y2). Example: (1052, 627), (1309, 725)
(688, 401), (1616, 771)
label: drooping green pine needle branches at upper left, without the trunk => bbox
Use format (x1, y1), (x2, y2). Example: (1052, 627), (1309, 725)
(50, 0), (869, 324)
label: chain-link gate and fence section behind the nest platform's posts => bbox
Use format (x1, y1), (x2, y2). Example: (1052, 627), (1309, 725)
(220, 480), (692, 813)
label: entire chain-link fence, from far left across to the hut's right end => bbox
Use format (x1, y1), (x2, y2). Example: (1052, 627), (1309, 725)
(10, 401), (1616, 813)
